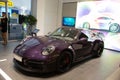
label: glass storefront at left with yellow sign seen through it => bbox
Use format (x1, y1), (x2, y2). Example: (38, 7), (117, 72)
(0, 0), (31, 40)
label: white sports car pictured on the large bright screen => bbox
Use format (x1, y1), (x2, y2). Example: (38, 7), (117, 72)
(76, 13), (120, 32)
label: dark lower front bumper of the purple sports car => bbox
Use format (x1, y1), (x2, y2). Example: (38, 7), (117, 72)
(13, 58), (56, 73)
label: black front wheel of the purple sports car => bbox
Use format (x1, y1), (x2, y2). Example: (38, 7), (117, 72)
(57, 51), (72, 73)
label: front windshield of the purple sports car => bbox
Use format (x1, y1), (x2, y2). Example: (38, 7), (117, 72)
(49, 28), (78, 41)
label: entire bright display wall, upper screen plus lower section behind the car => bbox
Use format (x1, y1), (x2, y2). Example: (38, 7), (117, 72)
(75, 0), (120, 51)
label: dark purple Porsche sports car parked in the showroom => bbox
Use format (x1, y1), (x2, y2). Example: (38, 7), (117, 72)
(13, 27), (104, 73)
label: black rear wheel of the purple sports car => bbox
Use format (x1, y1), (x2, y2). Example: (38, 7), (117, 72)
(93, 42), (104, 57)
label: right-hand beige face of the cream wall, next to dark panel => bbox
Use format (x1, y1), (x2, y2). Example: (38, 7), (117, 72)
(44, 0), (58, 34)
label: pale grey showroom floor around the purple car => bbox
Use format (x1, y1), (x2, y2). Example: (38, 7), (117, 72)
(0, 41), (120, 80)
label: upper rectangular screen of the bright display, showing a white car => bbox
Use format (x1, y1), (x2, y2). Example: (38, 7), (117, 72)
(76, 0), (120, 33)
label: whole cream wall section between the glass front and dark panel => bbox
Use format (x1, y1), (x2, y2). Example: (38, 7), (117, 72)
(32, 0), (59, 35)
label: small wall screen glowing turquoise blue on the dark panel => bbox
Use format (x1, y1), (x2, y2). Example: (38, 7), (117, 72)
(62, 17), (76, 27)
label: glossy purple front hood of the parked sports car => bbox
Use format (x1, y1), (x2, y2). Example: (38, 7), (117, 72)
(14, 36), (68, 60)
